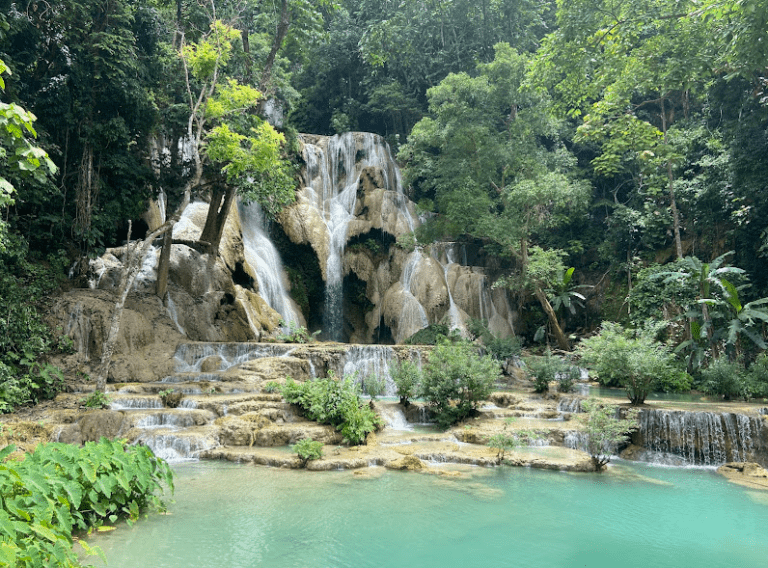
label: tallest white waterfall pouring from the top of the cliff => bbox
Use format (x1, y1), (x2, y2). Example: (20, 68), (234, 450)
(304, 132), (414, 341)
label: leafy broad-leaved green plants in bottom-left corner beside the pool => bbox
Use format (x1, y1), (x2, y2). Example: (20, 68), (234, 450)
(0, 438), (173, 568)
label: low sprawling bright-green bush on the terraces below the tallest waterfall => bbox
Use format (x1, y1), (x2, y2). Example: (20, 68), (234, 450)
(280, 377), (382, 445)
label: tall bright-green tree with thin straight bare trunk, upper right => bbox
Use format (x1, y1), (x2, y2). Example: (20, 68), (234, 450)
(531, 0), (717, 258)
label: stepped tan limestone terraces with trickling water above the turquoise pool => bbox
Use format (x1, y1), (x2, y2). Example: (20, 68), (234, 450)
(18, 343), (768, 471)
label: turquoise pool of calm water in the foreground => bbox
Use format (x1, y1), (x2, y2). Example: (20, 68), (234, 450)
(92, 462), (768, 568)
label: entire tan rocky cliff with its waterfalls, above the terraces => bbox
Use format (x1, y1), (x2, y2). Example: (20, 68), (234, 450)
(70, 133), (515, 360)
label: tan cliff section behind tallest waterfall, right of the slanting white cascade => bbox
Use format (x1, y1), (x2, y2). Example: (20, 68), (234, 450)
(280, 132), (514, 343)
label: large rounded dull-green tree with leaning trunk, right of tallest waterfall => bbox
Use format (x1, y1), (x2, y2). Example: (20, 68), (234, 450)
(399, 43), (590, 349)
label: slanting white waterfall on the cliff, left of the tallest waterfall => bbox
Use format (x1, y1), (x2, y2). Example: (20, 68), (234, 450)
(238, 203), (300, 326)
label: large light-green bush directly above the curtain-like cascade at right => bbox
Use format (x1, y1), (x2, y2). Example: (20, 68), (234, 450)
(579, 322), (680, 405)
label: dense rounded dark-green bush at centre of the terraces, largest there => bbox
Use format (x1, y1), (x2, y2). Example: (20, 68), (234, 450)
(421, 340), (499, 428)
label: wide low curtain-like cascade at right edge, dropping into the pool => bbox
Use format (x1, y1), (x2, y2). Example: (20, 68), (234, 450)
(633, 410), (763, 466)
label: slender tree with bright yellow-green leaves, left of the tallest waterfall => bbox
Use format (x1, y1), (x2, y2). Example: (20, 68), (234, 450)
(157, 20), (294, 297)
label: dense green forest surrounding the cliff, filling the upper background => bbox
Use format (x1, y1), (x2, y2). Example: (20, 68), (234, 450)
(0, 0), (768, 410)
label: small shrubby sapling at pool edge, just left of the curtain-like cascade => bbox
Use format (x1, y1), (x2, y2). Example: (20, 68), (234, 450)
(579, 399), (639, 472)
